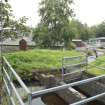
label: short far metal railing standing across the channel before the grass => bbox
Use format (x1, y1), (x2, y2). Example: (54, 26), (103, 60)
(62, 56), (88, 80)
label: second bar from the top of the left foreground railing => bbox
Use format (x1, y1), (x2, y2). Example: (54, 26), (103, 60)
(3, 68), (25, 105)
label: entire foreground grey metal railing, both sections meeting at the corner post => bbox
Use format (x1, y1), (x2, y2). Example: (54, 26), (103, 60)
(2, 57), (105, 105)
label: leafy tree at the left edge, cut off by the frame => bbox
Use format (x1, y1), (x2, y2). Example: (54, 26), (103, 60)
(0, 0), (30, 40)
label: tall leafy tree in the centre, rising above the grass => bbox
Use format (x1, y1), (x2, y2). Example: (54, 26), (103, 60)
(34, 0), (74, 47)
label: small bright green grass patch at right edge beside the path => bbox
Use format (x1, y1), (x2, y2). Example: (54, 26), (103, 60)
(87, 55), (105, 75)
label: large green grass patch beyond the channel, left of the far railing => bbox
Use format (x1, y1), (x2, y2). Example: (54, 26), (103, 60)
(5, 49), (80, 72)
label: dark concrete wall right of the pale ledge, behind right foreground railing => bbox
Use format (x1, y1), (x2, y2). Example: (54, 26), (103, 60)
(76, 77), (105, 103)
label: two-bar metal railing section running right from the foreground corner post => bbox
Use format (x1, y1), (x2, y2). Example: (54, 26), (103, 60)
(32, 75), (105, 105)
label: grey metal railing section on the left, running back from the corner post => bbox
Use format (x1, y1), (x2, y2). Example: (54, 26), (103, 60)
(2, 57), (31, 105)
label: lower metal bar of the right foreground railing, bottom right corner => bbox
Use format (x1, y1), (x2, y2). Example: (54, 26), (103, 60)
(70, 92), (105, 105)
